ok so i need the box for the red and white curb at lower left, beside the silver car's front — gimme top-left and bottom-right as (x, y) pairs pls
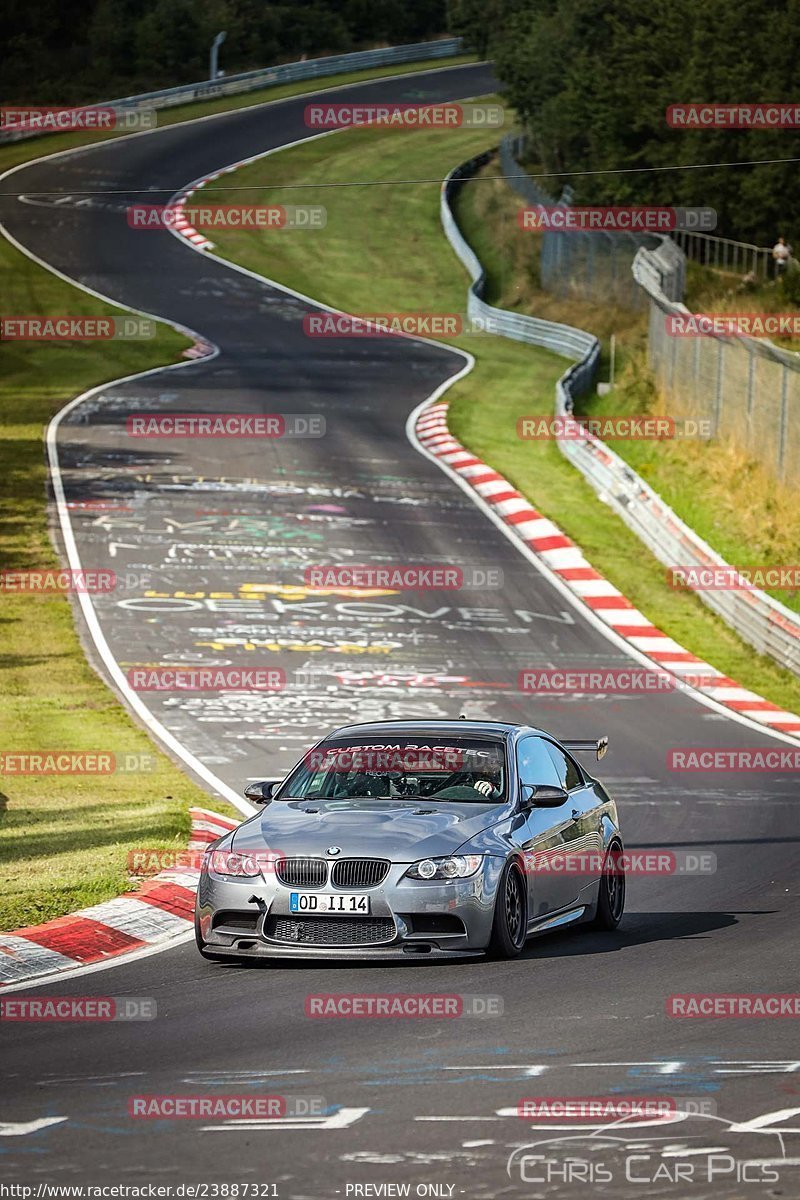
(0, 809), (239, 988)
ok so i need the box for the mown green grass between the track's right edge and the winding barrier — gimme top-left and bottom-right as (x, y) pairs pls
(204, 108), (800, 710)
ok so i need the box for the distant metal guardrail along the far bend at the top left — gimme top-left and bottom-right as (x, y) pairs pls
(0, 37), (463, 142)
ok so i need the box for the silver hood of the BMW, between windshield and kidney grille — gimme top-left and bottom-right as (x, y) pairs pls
(233, 799), (509, 863)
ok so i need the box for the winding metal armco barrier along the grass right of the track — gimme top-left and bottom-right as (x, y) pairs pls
(441, 151), (800, 674)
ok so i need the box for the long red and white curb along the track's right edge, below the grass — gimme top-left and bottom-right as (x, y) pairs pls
(415, 401), (800, 734)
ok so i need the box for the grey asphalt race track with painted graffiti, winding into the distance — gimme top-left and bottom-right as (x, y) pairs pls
(0, 66), (800, 1200)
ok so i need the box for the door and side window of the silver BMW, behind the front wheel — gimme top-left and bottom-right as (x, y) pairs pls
(517, 734), (579, 920)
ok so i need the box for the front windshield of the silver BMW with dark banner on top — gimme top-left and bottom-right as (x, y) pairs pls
(277, 737), (506, 804)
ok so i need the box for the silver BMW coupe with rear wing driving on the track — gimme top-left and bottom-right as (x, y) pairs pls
(194, 720), (625, 960)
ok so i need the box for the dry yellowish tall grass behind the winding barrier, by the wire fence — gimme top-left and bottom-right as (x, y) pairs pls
(459, 152), (800, 612)
